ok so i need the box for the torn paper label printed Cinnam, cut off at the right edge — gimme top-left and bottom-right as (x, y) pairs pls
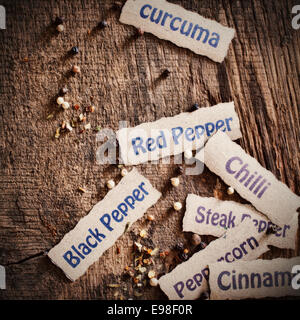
(209, 257), (300, 300)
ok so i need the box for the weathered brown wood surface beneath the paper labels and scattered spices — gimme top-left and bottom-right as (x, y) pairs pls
(0, 0), (300, 299)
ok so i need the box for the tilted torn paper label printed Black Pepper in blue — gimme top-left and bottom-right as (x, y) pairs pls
(48, 169), (161, 281)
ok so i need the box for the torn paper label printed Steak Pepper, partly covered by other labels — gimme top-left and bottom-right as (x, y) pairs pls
(183, 194), (298, 249)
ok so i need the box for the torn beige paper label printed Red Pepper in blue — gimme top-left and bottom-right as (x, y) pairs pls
(117, 102), (241, 165)
